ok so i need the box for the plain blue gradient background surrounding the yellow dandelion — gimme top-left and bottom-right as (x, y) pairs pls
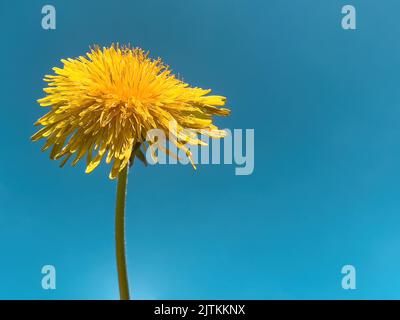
(0, 0), (400, 299)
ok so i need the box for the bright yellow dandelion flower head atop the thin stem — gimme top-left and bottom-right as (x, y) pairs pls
(31, 45), (230, 179)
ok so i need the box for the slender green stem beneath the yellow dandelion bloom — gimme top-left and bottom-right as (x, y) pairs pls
(115, 165), (129, 300)
